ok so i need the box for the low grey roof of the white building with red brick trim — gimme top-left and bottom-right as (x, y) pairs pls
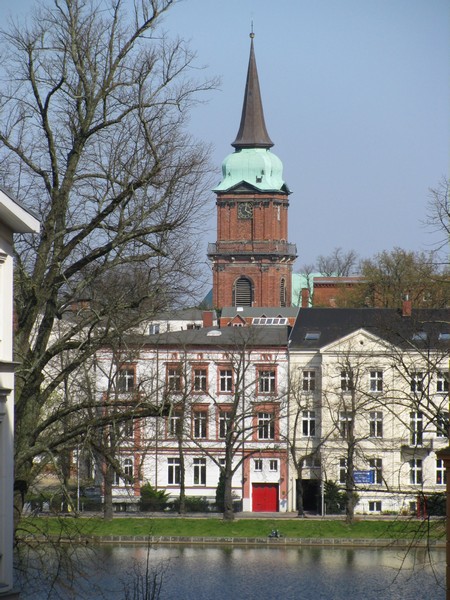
(127, 326), (288, 350)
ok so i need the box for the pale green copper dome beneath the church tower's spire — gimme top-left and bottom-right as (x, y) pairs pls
(214, 148), (286, 192)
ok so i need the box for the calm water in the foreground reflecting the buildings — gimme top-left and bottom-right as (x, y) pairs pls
(15, 545), (445, 600)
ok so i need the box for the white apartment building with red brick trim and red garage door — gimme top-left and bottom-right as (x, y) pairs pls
(96, 325), (288, 512)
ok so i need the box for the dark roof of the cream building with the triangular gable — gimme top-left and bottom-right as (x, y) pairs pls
(290, 308), (450, 351)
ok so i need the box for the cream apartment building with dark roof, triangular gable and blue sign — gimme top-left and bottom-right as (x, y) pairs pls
(289, 305), (450, 514)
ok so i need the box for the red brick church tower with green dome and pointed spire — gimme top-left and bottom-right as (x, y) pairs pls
(208, 33), (297, 308)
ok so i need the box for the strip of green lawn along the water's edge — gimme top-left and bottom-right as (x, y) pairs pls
(16, 517), (445, 539)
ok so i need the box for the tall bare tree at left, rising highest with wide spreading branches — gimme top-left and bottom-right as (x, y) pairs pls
(0, 0), (215, 510)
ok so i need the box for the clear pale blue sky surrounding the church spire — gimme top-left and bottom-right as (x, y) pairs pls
(0, 0), (450, 270)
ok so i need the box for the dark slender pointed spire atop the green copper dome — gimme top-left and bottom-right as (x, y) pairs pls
(231, 33), (273, 150)
